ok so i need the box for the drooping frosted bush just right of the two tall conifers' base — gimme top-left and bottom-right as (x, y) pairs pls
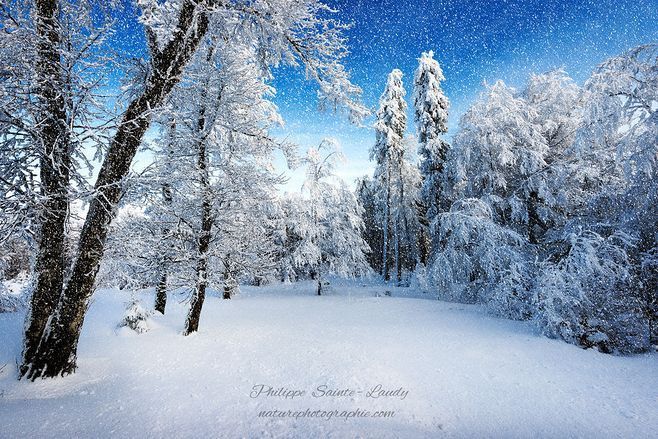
(429, 198), (532, 318)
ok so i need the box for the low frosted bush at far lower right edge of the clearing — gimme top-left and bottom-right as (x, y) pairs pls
(536, 231), (649, 352)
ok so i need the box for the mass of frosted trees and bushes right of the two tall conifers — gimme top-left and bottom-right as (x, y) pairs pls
(428, 45), (658, 353)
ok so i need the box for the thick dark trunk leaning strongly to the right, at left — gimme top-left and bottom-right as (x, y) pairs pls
(21, 0), (208, 380)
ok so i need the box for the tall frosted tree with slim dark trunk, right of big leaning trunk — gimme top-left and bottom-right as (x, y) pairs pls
(168, 43), (280, 334)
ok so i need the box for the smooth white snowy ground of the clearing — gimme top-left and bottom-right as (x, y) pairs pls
(0, 283), (658, 438)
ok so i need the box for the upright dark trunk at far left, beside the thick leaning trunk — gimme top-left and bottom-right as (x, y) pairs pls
(20, 0), (71, 376)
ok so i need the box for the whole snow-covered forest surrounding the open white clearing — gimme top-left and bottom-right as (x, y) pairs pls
(0, 0), (658, 380)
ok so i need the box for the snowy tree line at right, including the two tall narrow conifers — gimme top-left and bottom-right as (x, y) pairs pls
(358, 44), (658, 353)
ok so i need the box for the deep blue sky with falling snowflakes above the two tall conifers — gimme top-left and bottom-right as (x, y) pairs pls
(266, 0), (658, 190)
